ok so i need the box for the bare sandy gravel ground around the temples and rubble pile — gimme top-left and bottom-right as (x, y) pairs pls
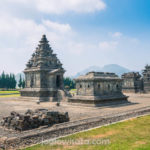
(0, 94), (150, 138)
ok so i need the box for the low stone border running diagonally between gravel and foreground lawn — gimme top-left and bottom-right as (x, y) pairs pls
(0, 107), (150, 149)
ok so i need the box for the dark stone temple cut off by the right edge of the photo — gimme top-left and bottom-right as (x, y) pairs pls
(143, 65), (150, 93)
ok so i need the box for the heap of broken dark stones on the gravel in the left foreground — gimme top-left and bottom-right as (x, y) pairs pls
(1, 109), (69, 131)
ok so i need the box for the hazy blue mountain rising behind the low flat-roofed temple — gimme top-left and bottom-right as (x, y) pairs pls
(74, 64), (131, 78)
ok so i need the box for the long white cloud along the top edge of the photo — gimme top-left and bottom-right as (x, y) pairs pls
(6, 0), (106, 14)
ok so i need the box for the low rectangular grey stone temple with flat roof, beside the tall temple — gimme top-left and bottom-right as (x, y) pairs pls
(69, 72), (127, 104)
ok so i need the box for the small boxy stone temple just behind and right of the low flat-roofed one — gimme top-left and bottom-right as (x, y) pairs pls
(122, 72), (143, 93)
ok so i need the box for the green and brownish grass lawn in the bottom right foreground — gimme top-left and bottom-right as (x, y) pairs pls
(26, 116), (150, 150)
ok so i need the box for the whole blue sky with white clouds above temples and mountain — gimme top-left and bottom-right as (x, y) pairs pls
(0, 0), (150, 76)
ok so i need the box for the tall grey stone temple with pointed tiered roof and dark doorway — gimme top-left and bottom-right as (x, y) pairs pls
(21, 35), (65, 101)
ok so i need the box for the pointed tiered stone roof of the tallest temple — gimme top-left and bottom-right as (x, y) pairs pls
(25, 35), (63, 70)
